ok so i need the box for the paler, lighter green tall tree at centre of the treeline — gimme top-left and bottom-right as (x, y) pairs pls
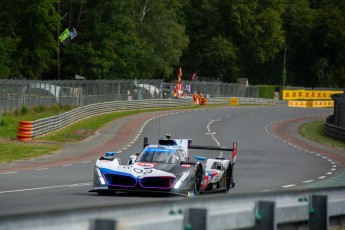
(133, 0), (189, 78)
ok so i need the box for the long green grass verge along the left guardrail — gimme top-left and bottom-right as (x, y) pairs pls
(0, 106), (203, 164)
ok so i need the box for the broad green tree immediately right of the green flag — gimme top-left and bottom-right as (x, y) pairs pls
(62, 0), (141, 79)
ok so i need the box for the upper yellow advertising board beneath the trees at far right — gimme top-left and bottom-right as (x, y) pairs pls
(283, 89), (344, 100)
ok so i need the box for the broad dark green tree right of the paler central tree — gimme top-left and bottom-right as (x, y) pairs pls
(183, 0), (285, 82)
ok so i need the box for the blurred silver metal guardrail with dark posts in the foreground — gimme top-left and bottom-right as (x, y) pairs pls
(0, 187), (345, 230)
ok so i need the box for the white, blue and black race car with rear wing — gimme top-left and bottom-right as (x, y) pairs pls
(90, 135), (237, 196)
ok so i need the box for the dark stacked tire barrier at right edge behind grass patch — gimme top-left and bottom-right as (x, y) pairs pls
(324, 94), (345, 140)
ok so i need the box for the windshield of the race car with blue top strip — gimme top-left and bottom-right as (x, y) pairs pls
(136, 148), (180, 164)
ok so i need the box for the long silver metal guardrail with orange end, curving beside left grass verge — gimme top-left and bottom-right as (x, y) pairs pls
(22, 97), (281, 140)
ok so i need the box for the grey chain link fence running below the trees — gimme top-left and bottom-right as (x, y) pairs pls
(0, 79), (259, 114)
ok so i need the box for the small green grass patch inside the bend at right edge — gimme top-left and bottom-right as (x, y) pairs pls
(299, 120), (345, 149)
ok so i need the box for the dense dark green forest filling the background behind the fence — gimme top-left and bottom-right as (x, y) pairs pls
(0, 0), (345, 87)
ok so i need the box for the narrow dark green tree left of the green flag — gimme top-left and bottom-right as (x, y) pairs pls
(6, 0), (59, 79)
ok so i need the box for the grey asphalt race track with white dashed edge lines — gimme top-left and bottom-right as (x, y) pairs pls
(0, 106), (345, 216)
